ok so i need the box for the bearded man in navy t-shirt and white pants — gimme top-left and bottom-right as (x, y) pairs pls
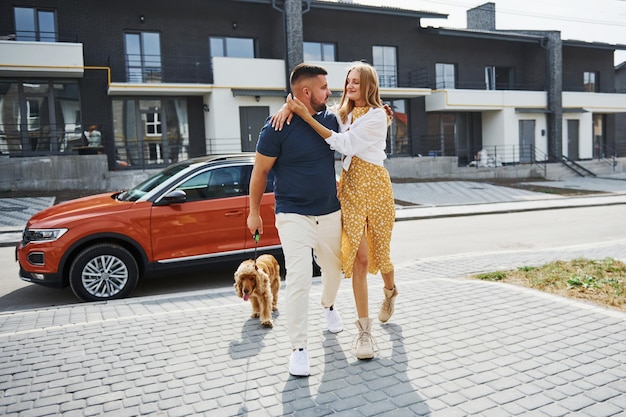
(248, 64), (343, 376)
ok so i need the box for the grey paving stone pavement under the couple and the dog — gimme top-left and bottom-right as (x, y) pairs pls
(0, 239), (626, 417)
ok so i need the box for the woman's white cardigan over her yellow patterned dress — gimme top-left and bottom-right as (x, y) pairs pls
(326, 108), (387, 171)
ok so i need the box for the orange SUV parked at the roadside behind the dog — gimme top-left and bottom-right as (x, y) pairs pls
(16, 153), (282, 301)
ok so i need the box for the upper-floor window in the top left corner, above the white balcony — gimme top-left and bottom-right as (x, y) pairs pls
(14, 7), (57, 42)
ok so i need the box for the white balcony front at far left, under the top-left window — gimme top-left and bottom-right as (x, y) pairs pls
(0, 41), (84, 78)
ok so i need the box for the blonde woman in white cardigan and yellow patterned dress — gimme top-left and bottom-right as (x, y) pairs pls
(287, 63), (398, 359)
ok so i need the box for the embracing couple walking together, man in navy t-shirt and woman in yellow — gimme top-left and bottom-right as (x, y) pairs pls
(247, 63), (398, 376)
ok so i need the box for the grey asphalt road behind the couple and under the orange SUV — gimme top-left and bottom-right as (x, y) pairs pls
(0, 205), (626, 312)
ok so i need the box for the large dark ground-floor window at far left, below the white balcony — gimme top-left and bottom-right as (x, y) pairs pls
(0, 80), (82, 155)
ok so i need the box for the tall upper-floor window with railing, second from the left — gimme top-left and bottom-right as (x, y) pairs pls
(124, 32), (162, 83)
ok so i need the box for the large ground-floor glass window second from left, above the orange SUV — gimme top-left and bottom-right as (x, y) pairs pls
(113, 97), (189, 169)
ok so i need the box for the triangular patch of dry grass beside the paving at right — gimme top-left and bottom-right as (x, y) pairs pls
(472, 258), (626, 312)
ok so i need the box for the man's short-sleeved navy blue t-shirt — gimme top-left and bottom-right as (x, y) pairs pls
(256, 110), (340, 216)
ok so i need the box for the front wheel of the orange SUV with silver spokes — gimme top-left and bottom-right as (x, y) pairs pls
(70, 243), (139, 301)
